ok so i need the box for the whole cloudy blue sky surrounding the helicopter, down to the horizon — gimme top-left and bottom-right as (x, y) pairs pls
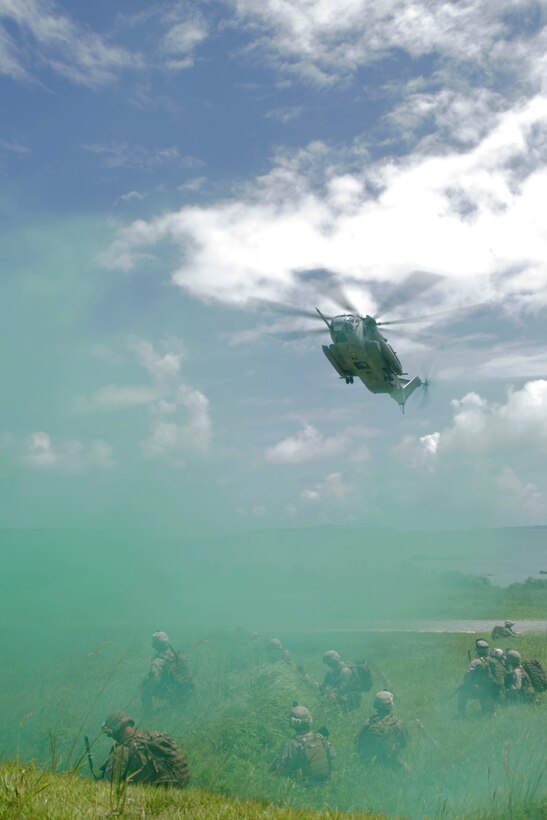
(0, 0), (547, 532)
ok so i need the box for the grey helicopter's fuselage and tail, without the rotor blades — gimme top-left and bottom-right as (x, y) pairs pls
(323, 314), (422, 407)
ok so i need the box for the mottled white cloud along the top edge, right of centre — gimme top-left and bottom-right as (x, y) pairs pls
(232, 0), (544, 90)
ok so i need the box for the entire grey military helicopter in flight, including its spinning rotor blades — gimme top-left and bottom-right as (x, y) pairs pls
(260, 271), (452, 413)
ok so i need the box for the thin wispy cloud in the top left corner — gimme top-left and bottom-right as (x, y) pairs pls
(0, 0), (142, 88)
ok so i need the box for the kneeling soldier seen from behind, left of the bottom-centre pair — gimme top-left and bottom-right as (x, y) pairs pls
(271, 706), (336, 782)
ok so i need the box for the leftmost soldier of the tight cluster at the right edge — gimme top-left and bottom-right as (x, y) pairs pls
(458, 638), (505, 717)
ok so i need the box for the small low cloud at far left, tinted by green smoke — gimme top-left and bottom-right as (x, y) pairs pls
(23, 432), (115, 473)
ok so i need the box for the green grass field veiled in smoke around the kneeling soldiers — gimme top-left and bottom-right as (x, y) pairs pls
(0, 629), (547, 817)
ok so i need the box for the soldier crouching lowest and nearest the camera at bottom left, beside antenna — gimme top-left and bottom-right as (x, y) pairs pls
(101, 712), (190, 789)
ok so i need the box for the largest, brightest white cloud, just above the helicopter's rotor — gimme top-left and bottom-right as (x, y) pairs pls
(109, 97), (547, 311)
